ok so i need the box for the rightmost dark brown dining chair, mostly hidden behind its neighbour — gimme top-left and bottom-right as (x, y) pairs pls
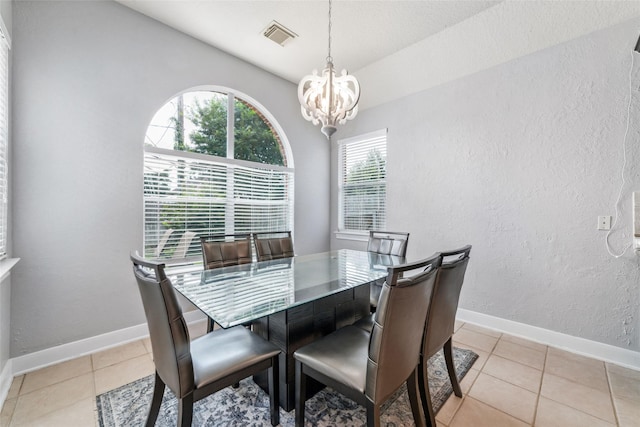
(418, 245), (471, 427)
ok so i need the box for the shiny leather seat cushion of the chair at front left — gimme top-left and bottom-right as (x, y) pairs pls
(191, 326), (280, 388)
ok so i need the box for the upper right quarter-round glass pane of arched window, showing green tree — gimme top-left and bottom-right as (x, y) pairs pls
(233, 99), (284, 165)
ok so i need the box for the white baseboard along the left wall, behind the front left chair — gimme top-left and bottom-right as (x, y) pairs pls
(9, 310), (206, 377)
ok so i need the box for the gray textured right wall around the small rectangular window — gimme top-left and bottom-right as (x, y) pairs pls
(332, 20), (640, 351)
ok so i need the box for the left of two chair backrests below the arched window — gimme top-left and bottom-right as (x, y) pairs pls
(200, 233), (252, 270)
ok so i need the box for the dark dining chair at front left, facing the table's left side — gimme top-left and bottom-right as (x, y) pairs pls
(130, 253), (280, 427)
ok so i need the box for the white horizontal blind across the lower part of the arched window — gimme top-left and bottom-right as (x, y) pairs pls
(144, 147), (294, 261)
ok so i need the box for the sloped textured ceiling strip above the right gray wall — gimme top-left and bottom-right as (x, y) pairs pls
(358, 0), (640, 108)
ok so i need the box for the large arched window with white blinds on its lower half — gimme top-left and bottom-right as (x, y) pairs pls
(144, 90), (293, 261)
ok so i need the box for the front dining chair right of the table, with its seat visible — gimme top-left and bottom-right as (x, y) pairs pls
(293, 254), (442, 427)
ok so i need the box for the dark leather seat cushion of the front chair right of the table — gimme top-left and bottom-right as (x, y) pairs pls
(293, 326), (370, 393)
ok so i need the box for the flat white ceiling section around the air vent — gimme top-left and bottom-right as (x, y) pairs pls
(116, 0), (500, 83)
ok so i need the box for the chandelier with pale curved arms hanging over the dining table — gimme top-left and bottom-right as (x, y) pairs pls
(298, 0), (360, 138)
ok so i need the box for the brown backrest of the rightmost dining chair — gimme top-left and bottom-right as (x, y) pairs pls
(422, 245), (471, 358)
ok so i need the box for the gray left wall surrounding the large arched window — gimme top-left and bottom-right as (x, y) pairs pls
(11, 1), (330, 357)
